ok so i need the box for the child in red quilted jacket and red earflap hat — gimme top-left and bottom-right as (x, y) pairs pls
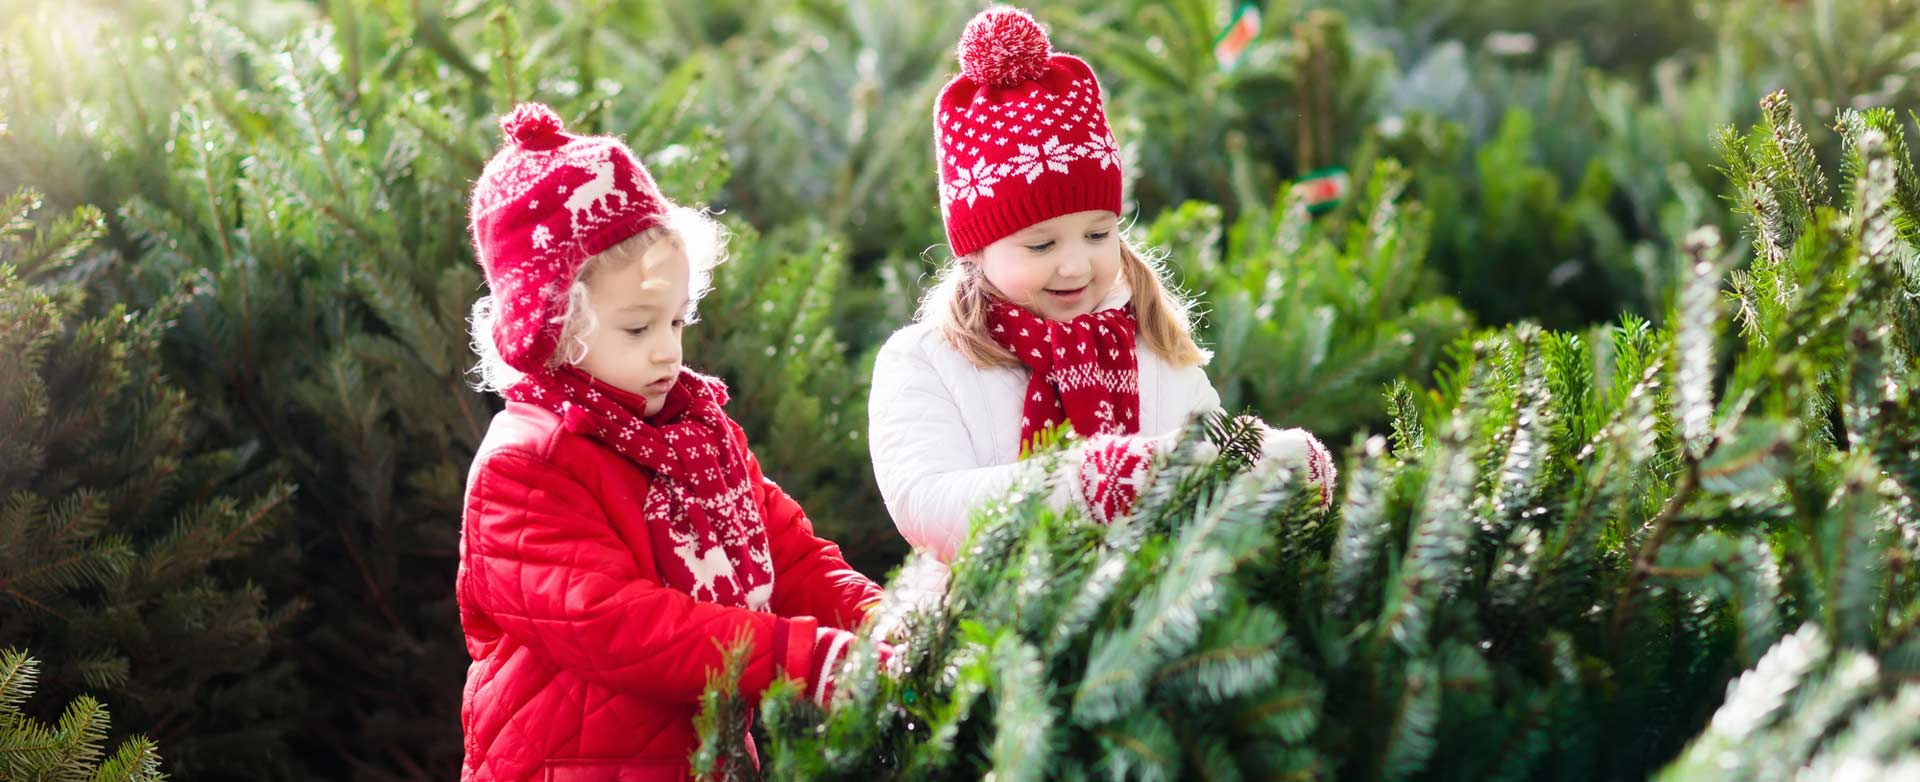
(457, 104), (879, 782)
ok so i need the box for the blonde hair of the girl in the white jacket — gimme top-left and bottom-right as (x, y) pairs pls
(914, 236), (1212, 369)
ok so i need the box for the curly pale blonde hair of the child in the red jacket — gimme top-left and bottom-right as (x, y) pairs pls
(467, 206), (728, 394)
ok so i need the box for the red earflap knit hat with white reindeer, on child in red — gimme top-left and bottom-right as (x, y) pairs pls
(470, 104), (672, 373)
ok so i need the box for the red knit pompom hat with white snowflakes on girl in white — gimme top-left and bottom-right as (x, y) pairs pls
(933, 6), (1121, 256)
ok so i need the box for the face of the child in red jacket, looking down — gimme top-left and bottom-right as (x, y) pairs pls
(578, 238), (689, 415)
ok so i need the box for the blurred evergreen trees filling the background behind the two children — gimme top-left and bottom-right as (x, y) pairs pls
(0, 0), (1920, 780)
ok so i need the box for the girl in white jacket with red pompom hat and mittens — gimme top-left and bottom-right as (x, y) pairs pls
(868, 8), (1334, 563)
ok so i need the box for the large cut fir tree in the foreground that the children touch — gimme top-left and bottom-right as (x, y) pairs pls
(701, 96), (1920, 780)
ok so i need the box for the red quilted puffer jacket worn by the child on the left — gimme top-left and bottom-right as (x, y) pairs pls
(457, 403), (879, 782)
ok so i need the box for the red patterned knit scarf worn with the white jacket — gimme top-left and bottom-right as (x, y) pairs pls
(989, 298), (1140, 453)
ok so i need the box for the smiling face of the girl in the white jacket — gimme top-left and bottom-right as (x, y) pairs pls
(970, 209), (1119, 321)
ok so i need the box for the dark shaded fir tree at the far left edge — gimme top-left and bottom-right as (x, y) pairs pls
(0, 183), (303, 776)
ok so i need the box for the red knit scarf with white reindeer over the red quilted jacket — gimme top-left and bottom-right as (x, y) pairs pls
(503, 367), (774, 611)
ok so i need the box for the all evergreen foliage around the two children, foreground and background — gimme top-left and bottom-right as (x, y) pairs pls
(0, 0), (1920, 780)
